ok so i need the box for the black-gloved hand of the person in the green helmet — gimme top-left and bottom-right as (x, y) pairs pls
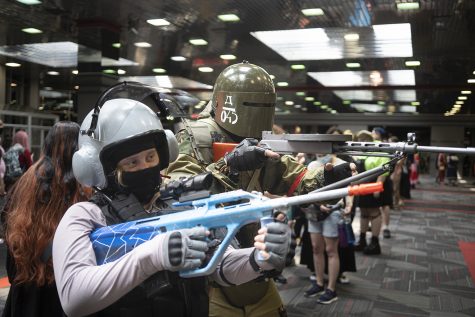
(224, 138), (267, 172)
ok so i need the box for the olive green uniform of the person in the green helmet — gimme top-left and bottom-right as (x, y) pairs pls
(167, 113), (324, 317)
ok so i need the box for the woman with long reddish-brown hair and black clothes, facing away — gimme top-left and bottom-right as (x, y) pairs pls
(2, 121), (88, 317)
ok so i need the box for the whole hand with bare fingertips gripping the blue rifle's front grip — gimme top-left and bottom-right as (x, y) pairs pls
(254, 222), (295, 271)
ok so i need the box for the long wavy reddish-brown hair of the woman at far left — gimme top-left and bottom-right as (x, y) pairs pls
(6, 121), (88, 286)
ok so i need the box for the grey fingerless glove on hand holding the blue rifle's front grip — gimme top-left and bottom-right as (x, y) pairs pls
(255, 222), (295, 271)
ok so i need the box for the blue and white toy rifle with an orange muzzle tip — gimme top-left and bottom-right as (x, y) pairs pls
(90, 183), (383, 277)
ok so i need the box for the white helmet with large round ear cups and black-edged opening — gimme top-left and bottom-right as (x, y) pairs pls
(73, 82), (178, 188)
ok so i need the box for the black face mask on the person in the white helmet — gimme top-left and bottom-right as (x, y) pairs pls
(122, 164), (162, 204)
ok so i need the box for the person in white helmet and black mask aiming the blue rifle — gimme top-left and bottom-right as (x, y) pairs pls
(53, 83), (288, 317)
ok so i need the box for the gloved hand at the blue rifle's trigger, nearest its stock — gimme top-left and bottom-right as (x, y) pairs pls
(162, 227), (209, 271)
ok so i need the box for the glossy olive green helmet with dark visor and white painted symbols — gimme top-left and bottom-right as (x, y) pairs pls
(211, 61), (276, 139)
